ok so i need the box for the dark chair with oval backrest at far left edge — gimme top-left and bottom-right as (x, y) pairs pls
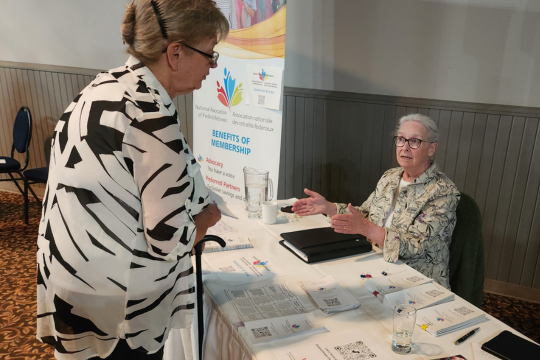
(0, 106), (32, 221)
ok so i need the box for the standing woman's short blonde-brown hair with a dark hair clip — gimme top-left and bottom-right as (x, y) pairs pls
(121, 0), (229, 65)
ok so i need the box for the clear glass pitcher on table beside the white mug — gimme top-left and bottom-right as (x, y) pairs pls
(244, 166), (274, 215)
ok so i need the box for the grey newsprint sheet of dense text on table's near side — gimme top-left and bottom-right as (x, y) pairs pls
(225, 284), (315, 322)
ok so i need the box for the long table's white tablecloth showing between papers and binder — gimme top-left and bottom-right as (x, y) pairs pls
(164, 200), (526, 360)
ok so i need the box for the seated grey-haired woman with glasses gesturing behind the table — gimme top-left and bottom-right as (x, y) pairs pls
(293, 114), (460, 289)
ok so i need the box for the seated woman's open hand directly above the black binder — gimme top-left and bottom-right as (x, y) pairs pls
(330, 204), (385, 248)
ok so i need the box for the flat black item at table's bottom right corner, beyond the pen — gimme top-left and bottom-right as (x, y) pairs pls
(482, 330), (540, 360)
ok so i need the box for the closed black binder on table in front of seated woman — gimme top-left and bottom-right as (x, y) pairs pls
(279, 227), (372, 264)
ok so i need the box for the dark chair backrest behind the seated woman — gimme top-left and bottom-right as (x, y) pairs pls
(450, 193), (485, 308)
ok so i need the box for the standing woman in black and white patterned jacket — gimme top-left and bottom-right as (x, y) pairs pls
(37, 0), (229, 359)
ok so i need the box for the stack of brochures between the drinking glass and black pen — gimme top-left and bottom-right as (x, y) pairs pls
(416, 298), (488, 336)
